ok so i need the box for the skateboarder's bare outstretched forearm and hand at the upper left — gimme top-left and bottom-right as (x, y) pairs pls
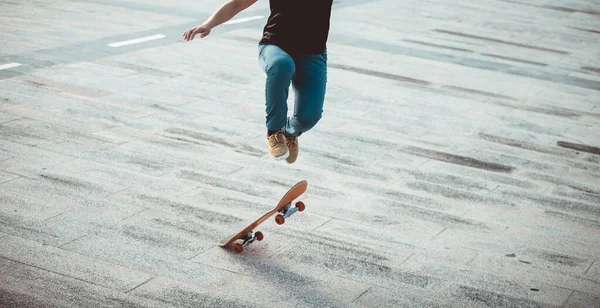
(183, 0), (258, 41)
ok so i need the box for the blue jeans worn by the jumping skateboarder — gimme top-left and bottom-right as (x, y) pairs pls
(258, 45), (327, 137)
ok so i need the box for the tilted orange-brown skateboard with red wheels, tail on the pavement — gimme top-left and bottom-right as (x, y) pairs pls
(218, 180), (308, 253)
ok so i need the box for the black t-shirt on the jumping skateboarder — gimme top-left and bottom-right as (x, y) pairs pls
(259, 0), (333, 54)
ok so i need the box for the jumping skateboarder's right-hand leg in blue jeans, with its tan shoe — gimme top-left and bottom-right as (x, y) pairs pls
(284, 51), (327, 163)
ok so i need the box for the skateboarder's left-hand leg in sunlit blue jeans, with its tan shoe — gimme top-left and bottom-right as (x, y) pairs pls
(259, 45), (296, 158)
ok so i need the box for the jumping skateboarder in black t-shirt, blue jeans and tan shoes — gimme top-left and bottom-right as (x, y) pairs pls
(183, 0), (333, 163)
